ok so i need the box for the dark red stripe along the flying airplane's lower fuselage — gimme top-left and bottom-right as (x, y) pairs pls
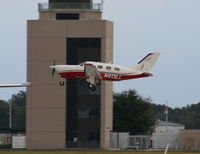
(59, 72), (152, 81)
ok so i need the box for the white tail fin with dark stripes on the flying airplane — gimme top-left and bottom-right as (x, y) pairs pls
(133, 52), (160, 73)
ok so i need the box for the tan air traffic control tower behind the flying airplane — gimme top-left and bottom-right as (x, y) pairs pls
(26, 0), (113, 149)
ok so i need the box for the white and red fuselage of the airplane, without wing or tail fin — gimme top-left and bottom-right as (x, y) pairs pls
(52, 61), (152, 81)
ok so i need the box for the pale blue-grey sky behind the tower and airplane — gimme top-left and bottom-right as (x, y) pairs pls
(0, 0), (200, 107)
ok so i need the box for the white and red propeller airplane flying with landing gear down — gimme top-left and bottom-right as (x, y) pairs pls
(49, 52), (160, 91)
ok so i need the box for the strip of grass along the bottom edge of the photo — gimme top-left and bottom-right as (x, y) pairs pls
(0, 150), (200, 154)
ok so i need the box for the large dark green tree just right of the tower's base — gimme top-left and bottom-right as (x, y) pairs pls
(113, 90), (156, 134)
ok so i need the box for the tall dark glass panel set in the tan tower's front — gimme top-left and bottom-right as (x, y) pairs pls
(66, 38), (101, 148)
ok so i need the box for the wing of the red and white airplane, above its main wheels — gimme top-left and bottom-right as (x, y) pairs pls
(85, 64), (102, 85)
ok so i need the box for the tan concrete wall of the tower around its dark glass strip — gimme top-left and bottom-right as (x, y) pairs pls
(26, 20), (113, 149)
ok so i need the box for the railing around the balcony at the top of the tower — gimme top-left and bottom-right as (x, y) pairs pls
(38, 3), (103, 12)
